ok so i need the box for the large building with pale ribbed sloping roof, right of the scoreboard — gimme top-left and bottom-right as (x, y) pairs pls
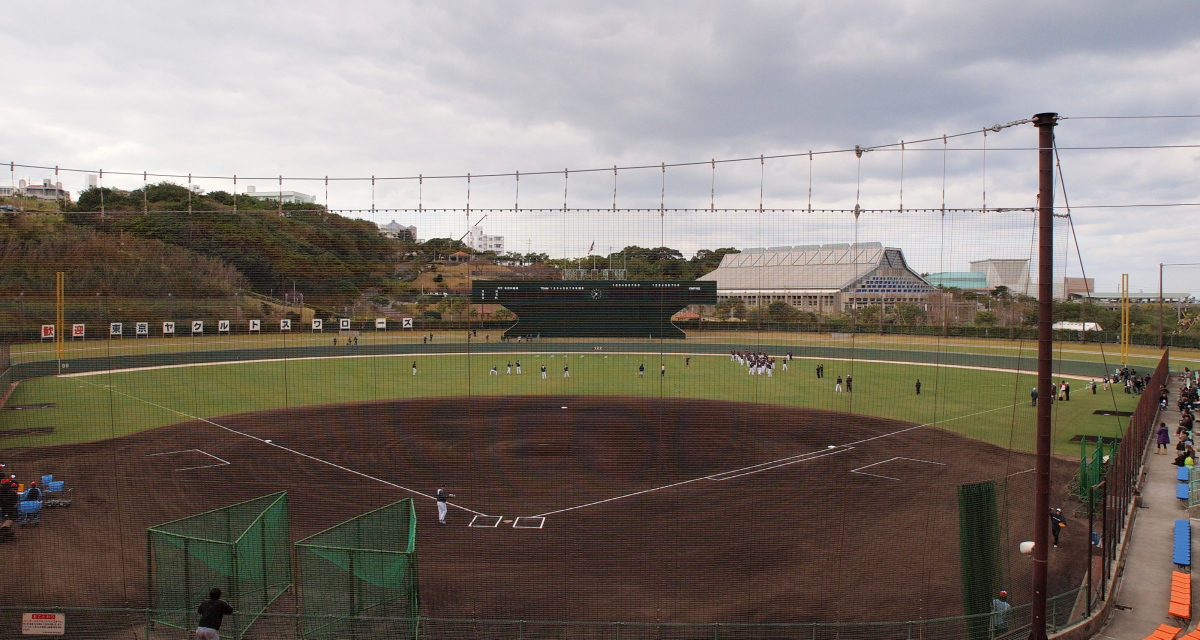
(697, 243), (936, 313)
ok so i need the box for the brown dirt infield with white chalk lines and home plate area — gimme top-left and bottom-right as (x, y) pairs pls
(0, 396), (1087, 623)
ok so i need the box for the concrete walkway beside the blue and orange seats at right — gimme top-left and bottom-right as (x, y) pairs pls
(1096, 377), (1196, 640)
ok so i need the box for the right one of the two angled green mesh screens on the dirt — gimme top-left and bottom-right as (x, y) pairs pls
(296, 498), (420, 639)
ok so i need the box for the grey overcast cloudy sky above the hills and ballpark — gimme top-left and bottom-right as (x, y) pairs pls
(0, 0), (1200, 292)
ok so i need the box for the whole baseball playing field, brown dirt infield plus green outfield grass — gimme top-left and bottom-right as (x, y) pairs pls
(0, 331), (1152, 622)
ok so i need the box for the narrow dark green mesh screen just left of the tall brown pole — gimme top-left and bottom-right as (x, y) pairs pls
(959, 480), (1002, 640)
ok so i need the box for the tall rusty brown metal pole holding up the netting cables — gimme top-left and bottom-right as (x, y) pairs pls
(1030, 113), (1058, 640)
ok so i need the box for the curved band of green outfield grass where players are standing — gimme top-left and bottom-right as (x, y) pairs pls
(0, 345), (1138, 455)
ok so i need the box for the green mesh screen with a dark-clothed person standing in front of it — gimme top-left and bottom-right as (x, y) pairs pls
(149, 491), (292, 638)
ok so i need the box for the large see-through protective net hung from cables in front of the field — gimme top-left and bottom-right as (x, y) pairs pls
(0, 121), (1180, 638)
